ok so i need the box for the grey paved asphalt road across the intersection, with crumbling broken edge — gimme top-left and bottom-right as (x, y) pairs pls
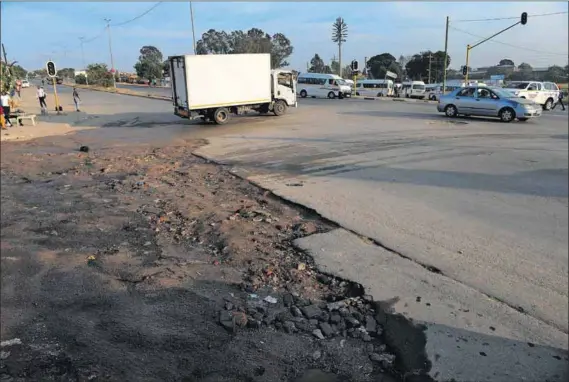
(16, 86), (569, 381)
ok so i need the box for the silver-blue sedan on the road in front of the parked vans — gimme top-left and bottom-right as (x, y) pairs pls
(437, 86), (541, 122)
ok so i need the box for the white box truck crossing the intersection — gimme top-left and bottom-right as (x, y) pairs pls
(168, 54), (297, 125)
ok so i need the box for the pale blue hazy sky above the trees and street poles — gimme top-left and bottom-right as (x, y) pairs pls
(1, 1), (569, 71)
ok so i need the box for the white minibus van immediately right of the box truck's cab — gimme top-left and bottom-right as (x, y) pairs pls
(296, 73), (352, 98)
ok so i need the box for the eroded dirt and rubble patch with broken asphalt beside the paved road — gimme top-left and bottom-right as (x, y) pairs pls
(0, 137), (408, 382)
